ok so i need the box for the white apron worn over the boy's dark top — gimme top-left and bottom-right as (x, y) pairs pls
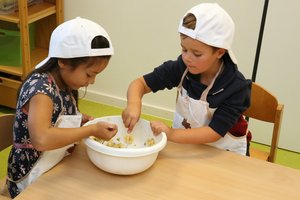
(173, 66), (247, 155)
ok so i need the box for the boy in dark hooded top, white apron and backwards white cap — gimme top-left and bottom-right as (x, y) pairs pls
(122, 3), (251, 155)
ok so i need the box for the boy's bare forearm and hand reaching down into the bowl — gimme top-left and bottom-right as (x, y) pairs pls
(122, 77), (151, 132)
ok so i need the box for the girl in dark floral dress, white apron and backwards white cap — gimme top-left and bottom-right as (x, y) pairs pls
(7, 17), (117, 198)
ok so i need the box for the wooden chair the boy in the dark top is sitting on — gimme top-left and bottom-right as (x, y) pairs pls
(244, 82), (284, 162)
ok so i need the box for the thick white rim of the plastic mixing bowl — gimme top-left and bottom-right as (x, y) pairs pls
(84, 116), (167, 157)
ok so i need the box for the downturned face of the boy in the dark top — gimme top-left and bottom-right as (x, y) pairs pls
(180, 36), (224, 74)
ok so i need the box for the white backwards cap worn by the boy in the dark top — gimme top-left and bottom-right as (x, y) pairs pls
(178, 3), (237, 64)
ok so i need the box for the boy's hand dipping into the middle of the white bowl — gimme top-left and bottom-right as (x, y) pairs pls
(122, 105), (141, 133)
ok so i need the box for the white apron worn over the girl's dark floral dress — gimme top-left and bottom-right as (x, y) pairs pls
(14, 84), (82, 192)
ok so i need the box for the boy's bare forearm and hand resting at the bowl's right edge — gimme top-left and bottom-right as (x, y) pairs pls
(151, 121), (221, 144)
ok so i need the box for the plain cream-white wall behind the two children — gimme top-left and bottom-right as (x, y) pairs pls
(65, 0), (300, 152)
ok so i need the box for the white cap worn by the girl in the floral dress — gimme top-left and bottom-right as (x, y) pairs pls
(35, 17), (114, 68)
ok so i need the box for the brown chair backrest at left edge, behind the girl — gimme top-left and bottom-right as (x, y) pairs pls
(0, 114), (15, 151)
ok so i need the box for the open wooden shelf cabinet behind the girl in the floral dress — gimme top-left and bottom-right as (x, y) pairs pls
(0, 0), (63, 108)
